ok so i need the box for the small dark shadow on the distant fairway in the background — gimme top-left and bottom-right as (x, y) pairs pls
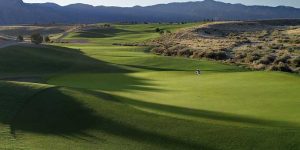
(74, 28), (135, 38)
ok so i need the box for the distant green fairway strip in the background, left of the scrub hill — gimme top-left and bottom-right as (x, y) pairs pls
(65, 23), (199, 46)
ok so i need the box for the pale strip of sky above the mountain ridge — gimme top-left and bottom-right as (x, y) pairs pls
(23, 0), (300, 8)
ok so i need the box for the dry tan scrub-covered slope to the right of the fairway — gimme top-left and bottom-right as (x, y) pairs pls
(150, 20), (300, 73)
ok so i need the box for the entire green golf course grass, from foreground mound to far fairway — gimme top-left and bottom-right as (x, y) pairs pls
(0, 23), (300, 150)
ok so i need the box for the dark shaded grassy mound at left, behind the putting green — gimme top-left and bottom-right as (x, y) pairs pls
(0, 45), (130, 74)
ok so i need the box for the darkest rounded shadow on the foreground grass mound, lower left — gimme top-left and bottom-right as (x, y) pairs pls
(11, 87), (97, 135)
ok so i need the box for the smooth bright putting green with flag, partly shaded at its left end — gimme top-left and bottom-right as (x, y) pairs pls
(49, 71), (300, 125)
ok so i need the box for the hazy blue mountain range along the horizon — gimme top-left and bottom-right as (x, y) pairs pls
(0, 0), (300, 25)
